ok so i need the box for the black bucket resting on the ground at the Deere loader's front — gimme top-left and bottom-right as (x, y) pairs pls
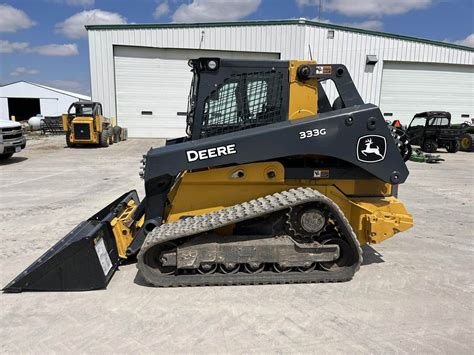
(3, 190), (140, 292)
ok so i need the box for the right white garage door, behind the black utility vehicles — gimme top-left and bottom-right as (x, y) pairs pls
(380, 62), (474, 124)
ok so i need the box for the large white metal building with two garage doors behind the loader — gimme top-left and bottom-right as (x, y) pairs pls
(87, 19), (474, 137)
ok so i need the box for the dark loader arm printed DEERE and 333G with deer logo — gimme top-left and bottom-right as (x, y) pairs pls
(144, 104), (408, 230)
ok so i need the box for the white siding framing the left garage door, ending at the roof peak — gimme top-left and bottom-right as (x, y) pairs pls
(88, 25), (305, 116)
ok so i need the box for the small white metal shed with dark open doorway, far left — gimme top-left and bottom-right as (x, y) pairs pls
(0, 81), (90, 121)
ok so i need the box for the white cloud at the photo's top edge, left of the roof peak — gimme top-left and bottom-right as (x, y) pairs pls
(173, 0), (261, 22)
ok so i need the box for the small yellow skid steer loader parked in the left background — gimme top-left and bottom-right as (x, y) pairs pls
(62, 101), (127, 147)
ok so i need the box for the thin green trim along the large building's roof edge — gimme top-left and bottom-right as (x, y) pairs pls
(86, 19), (474, 52)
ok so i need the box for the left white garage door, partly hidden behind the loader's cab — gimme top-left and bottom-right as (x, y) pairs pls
(114, 47), (279, 138)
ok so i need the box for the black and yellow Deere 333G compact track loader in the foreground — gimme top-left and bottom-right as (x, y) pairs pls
(4, 58), (413, 292)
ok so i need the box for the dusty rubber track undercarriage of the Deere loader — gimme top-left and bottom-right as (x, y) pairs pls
(138, 188), (362, 286)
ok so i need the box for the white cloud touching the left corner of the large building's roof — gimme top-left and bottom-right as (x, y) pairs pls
(55, 9), (127, 38)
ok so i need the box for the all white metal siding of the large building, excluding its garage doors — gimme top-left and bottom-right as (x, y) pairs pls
(89, 22), (474, 132)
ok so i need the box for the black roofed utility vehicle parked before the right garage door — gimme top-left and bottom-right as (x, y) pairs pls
(407, 111), (462, 153)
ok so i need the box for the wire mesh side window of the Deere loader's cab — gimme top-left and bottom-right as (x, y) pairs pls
(201, 72), (283, 137)
